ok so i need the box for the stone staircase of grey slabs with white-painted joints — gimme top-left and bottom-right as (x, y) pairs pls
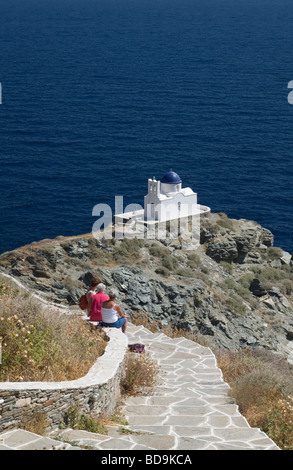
(0, 324), (279, 450)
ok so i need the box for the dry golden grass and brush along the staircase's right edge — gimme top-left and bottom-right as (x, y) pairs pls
(215, 349), (293, 450)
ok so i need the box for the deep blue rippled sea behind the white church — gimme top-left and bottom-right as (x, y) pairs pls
(0, 0), (293, 252)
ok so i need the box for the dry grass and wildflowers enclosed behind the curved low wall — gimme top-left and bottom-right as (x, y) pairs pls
(0, 282), (107, 382)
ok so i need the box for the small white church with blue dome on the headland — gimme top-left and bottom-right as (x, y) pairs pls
(115, 170), (210, 233)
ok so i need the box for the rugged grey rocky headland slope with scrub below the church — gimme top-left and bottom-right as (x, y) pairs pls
(0, 214), (293, 362)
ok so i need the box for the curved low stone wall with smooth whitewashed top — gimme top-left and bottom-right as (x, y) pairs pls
(0, 328), (128, 432)
